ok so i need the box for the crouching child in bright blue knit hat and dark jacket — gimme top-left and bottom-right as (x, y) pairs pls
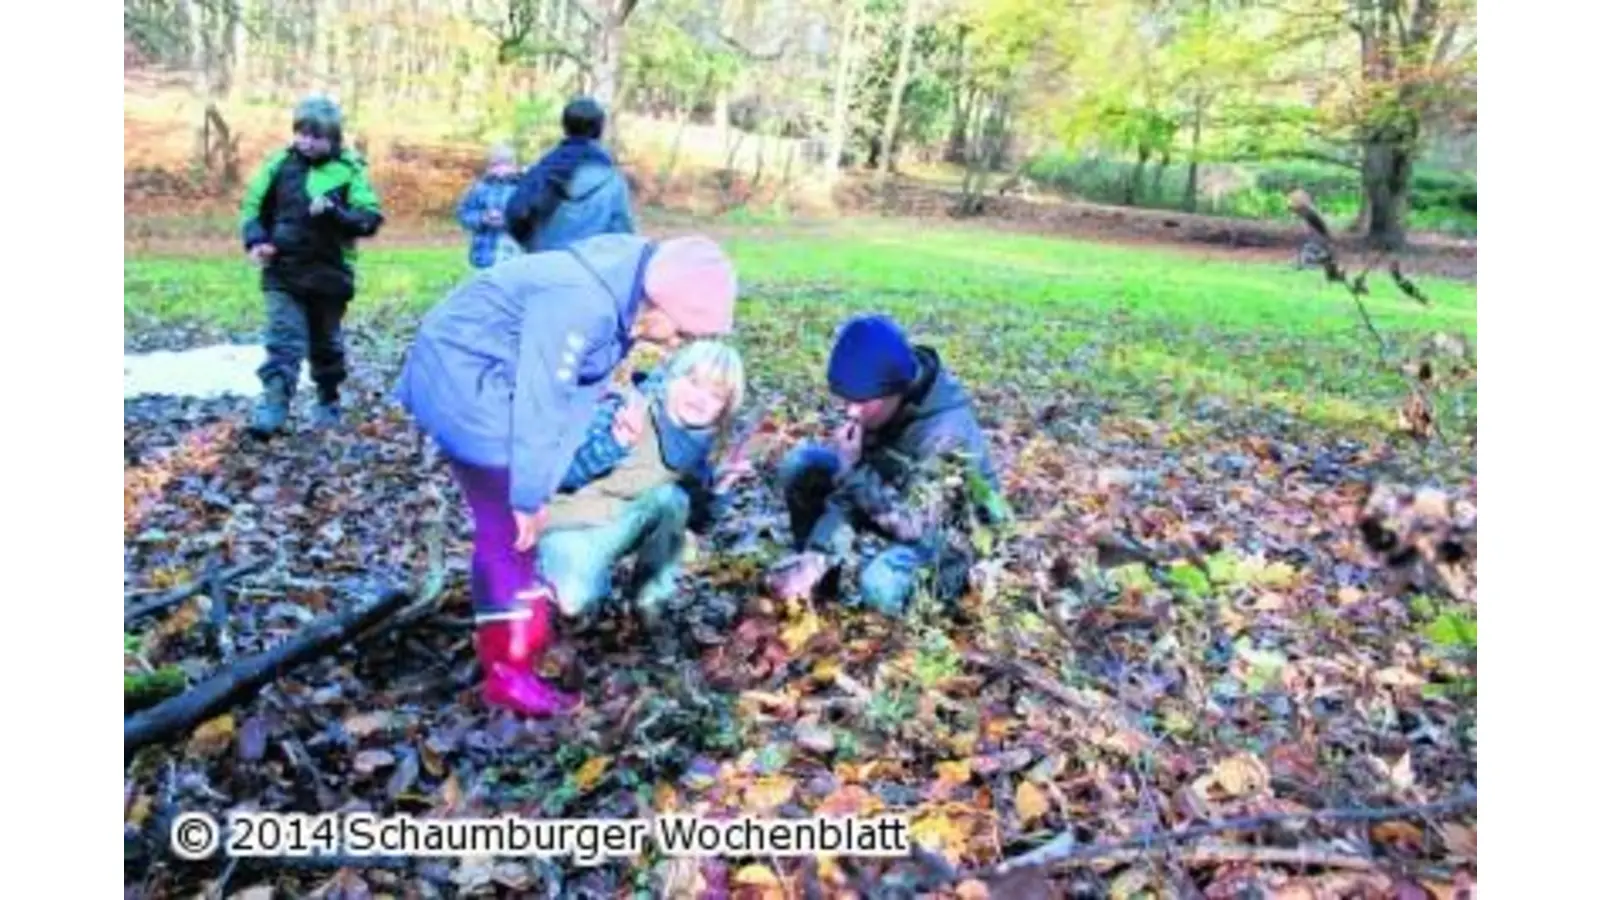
(771, 315), (1010, 617)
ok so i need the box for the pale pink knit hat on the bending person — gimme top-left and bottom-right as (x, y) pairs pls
(645, 235), (739, 336)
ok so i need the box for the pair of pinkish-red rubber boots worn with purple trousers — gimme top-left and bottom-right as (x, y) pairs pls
(477, 597), (579, 719)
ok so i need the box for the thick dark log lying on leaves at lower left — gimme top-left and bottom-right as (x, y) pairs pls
(122, 591), (410, 759)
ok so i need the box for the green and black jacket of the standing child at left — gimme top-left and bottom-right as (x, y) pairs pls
(240, 147), (384, 303)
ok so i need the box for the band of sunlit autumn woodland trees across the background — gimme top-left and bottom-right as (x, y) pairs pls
(123, 0), (1475, 240)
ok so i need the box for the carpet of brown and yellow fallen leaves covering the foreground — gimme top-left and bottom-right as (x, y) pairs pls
(128, 281), (1475, 898)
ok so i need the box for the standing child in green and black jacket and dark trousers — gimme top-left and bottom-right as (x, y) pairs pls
(240, 96), (384, 437)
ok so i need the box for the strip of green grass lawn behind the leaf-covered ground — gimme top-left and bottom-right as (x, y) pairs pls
(123, 217), (1477, 454)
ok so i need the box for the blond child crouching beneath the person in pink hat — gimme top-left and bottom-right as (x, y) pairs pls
(539, 341), (744, 626)
